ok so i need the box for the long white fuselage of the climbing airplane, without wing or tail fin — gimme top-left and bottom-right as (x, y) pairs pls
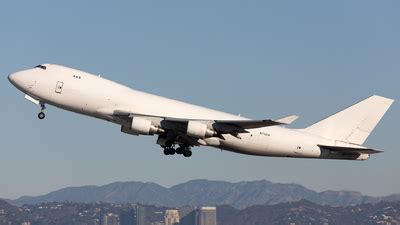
(9, 64), (368, 160)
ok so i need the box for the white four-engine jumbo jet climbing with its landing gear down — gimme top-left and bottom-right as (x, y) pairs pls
(8, 64), (394, 160)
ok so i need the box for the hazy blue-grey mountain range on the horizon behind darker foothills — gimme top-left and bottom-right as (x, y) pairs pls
(3, 180), (400, 209)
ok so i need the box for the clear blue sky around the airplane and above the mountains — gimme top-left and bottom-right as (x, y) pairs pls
(0, 0), (400, 198)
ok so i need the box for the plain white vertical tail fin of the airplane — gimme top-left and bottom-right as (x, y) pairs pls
(304, 95), (394, 145)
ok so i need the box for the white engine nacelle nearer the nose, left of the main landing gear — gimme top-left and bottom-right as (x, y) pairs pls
(121, 117), (163, 135)
